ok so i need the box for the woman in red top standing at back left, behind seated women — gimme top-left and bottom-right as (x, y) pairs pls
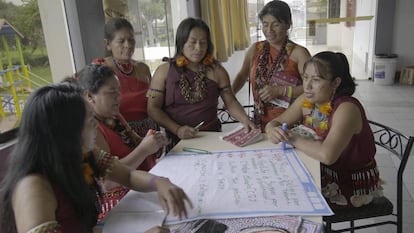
(92, 18), (158, 171)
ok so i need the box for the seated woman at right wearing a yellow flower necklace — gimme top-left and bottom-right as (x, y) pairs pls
(266, 52), (382, 209)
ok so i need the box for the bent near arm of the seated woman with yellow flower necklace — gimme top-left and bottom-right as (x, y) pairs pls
(288, 102), (362, 165)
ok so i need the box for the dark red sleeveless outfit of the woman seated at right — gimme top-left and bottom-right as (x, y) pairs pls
(306, 96), (381, 209)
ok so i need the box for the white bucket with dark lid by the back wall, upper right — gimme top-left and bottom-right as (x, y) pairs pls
(374, 54), (397, 85)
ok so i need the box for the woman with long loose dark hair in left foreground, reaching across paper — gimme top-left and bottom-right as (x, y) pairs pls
(0, 83), (191, 233)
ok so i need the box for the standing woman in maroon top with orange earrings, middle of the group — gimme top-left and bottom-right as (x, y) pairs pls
(148, 18), (254, 147)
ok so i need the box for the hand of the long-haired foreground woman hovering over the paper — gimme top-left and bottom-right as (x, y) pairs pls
(154, 177), (193, 220)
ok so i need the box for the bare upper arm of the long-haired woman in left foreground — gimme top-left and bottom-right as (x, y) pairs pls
(12, 175), (57, 233)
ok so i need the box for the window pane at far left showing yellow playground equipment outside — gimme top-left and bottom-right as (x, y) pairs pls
(0, 0), (52, 142)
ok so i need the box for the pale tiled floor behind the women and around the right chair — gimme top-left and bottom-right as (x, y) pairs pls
(223, 51), (414, 233)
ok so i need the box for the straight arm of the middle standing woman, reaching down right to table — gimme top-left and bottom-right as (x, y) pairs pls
(214, 65), (256, 129)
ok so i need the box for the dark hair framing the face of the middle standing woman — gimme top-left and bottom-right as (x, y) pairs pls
(174, 18), (214, 57)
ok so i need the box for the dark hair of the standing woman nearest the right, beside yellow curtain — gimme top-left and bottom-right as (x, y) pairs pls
(259, 0), (292, 25)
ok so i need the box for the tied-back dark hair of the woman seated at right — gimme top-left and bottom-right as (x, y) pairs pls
(303, 51), (356, 97)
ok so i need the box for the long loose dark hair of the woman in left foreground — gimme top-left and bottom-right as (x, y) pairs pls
(0, 83), (97, 233)
